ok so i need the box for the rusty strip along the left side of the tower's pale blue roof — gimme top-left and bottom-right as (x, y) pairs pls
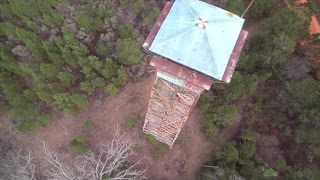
(142, 1), (173, 49)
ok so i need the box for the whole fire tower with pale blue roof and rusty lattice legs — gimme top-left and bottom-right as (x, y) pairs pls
(143, 0), (248, 148)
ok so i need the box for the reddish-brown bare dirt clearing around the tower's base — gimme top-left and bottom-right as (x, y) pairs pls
(1, 74), (240, 180)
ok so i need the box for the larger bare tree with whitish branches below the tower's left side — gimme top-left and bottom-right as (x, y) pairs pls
(43, 130), (146, 180)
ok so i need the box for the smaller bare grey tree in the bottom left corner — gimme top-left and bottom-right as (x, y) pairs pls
(2, 150), (36, 180)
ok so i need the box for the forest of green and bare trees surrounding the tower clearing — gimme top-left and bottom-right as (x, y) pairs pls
(0, 0), (320, 180)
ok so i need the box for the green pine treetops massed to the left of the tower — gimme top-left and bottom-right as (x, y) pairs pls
(0, 0), (135, 132)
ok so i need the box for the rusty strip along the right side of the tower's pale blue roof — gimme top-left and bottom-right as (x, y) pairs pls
(221, 30), (248, 83)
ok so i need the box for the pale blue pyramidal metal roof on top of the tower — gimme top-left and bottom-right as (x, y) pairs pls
(149, 0), (244, 80)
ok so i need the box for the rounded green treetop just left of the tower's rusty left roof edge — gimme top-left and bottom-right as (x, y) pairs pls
(116, 39), (143, 65)
